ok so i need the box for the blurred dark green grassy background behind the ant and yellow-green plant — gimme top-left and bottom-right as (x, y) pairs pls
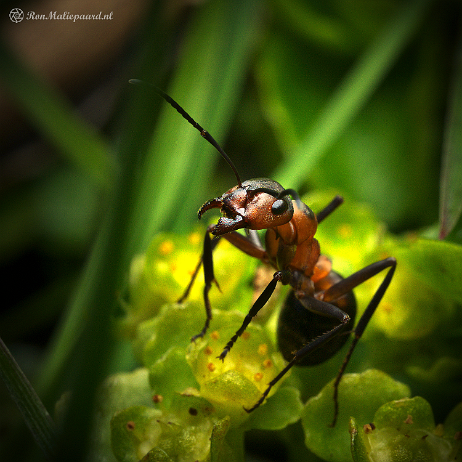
(0, 0), (462, 460)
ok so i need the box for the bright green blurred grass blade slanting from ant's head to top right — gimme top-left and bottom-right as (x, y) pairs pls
(274, 0), (430, 189)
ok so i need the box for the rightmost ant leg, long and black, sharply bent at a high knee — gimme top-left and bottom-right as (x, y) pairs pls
(324, 257), (396, 427)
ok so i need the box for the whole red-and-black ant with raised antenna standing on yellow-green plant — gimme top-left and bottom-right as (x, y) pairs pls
(130, 80), (396, 427)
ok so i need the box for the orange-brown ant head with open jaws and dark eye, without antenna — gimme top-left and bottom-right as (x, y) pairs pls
(198, 178), (294, 236)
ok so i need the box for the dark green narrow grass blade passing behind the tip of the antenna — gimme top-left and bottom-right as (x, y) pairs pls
(37, 11), (165, 401)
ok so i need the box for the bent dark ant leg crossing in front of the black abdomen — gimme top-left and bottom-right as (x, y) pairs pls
(244, 297), (350, 412)
